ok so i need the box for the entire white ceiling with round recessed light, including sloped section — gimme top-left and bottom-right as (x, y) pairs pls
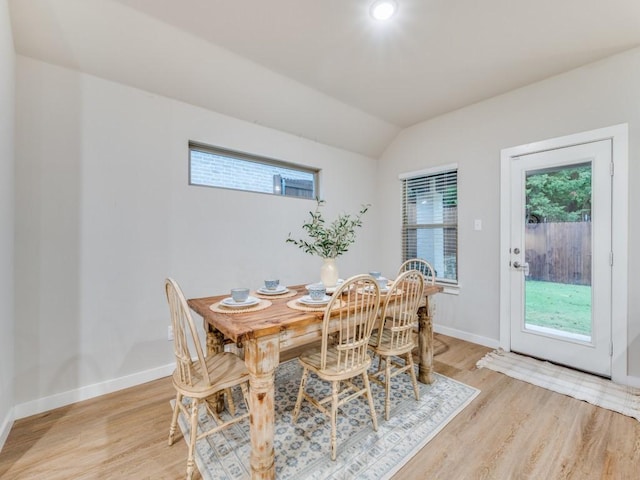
(10, 0), (640, 156)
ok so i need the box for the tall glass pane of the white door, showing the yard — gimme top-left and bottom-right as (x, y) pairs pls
(524, 162), (592, 342)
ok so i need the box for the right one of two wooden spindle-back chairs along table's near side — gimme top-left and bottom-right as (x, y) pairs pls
(369, 270), (424, 420)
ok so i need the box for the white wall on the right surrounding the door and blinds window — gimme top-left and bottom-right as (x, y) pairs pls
(378, 49), (640, 377)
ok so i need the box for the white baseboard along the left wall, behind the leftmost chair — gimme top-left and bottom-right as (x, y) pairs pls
(13, 363), (175, 419)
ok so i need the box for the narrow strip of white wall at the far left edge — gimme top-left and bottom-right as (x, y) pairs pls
(0, 0), (15, 448)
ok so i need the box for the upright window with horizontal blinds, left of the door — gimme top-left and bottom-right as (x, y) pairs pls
(400, 165), (458, 284)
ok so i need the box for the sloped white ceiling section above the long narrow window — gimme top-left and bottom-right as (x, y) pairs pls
(11, 0), (400, 156)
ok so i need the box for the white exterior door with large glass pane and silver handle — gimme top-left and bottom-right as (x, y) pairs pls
(509, 140), (612, 376)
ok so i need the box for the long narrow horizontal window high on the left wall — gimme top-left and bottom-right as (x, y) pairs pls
(189, 142), (318, 198)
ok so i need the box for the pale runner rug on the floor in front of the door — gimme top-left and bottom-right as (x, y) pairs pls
(477, 349), (640, 420)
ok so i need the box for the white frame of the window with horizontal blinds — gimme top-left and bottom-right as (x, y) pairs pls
(398, 163), (460, 287)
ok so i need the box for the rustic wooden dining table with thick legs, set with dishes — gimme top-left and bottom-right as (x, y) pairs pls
(188, 285), (442, 479)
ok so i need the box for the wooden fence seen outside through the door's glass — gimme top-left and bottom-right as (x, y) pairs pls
(525, 222), (591, 285)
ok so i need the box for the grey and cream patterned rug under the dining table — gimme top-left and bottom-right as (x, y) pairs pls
(172, 360), (480, 480)
